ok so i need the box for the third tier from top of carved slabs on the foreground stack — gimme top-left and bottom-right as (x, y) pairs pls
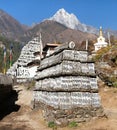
(35, 76), (98, 92)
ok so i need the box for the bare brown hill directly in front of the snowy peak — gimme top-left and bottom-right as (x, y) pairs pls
(28, 20), (96, 44)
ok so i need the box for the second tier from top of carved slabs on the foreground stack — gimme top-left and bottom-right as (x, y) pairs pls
(35, 61), (95, 79)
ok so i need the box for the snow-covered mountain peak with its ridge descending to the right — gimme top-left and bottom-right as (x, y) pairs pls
(49, 8), (97, 34)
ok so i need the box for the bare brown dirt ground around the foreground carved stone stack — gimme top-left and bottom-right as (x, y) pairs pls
(0, 82), (117, 130)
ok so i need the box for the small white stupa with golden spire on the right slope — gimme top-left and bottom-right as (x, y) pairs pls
(94, 27), (108, 52)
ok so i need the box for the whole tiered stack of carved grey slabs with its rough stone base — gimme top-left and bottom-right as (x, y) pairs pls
(34, 42), (102, 124)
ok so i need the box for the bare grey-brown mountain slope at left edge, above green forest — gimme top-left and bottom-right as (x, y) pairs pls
(0, 9), (26, 40)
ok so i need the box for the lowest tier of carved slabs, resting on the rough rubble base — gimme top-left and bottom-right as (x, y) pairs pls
(33, 91), (101, 109)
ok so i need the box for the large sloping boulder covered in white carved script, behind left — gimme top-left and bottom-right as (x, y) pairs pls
(7, 37), (42, 83)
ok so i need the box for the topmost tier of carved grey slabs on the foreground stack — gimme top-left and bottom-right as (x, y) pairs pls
(38, 50), (88, 70)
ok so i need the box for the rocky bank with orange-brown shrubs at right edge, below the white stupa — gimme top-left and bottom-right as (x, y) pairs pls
(94, 44), (117, 87)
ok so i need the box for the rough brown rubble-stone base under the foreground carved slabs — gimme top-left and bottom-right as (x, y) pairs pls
(35, 101), (104, 126)
